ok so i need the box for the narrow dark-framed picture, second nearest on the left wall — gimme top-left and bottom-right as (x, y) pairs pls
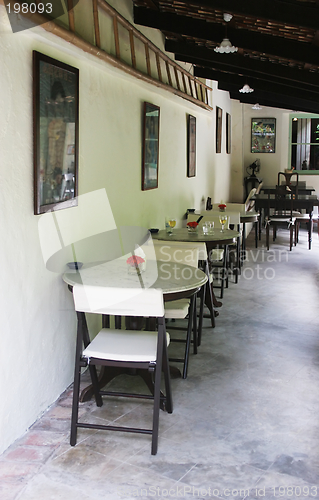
(142, 102), (160, 191)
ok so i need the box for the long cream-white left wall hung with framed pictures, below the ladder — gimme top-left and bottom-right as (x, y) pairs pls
(0, 6), (230, 453)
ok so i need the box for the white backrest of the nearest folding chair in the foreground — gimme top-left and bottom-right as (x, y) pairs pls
(73, 285), (164, 318)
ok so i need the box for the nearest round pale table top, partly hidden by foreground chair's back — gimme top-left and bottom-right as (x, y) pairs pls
(63, 258), (207, 300)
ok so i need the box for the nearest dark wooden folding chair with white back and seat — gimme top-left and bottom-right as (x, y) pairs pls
(70, 285), (173, 455)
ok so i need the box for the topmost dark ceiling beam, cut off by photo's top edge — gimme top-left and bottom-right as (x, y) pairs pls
(160, 0), (319, 30)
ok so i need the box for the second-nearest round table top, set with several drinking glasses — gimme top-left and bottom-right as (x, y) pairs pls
(152, 228), (240, 245)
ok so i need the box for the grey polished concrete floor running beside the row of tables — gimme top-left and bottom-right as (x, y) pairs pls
(0, 231), (319, 500)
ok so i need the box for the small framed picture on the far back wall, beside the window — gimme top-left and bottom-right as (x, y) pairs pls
(251, 118), (276, 153)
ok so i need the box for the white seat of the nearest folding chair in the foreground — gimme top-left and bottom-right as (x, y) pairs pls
(83, 328), (170, 362)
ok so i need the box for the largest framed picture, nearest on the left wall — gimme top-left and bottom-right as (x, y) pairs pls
(33, 51), (79, 215)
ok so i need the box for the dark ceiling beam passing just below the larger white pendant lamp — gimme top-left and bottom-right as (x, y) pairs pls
(165, 40), (319, 87)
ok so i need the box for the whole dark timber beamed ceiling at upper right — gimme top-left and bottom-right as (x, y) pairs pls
(133, 0), (319, 113)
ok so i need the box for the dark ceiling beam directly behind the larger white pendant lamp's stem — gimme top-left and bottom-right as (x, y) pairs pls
(134, 7), (319, 65)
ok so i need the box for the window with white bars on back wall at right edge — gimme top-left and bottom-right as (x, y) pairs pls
(290, 114), (319, 171)
